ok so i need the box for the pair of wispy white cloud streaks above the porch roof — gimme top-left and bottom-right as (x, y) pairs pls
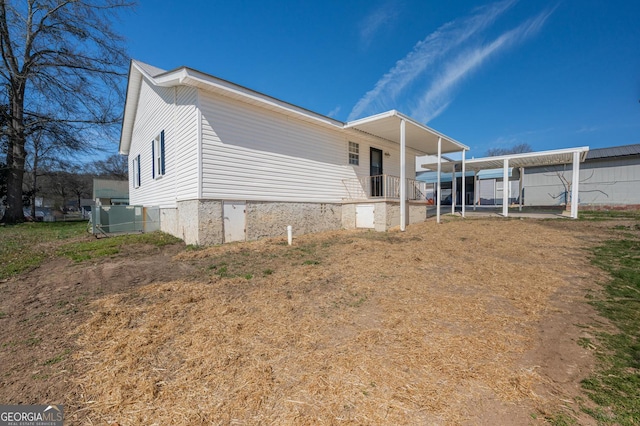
(348, 0), (553, 121)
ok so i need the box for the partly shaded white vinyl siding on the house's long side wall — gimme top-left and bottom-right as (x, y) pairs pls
(200, 92), (356, 202)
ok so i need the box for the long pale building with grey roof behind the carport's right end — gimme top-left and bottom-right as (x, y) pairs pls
(524, 144), (640, 207)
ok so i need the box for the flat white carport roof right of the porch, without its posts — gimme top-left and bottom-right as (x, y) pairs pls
(422, 146), (589, 171)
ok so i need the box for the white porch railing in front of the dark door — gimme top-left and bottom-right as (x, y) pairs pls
(342, 175), (429, 201)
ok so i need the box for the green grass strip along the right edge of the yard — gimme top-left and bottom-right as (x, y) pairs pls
(579, 225), (640, 425)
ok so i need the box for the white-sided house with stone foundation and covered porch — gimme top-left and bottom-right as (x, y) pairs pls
(120, 61), (468, 244)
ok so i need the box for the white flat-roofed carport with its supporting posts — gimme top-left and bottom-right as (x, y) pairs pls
(422, 146), (589, 222)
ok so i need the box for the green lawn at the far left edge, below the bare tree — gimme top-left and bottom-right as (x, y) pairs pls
(0, 222), (87, 279)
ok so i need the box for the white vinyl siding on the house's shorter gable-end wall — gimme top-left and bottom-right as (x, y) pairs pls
(130, 80), (198, 207)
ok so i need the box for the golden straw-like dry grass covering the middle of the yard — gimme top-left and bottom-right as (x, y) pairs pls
(71, 220), (596, 425)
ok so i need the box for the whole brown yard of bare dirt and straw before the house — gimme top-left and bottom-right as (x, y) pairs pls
(0, 219), (612, 425)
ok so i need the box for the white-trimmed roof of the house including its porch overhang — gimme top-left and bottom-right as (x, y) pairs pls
(119, 60), (469, 155)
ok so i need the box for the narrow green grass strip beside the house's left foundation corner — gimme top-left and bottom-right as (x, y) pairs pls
(58, 231), (181, 262)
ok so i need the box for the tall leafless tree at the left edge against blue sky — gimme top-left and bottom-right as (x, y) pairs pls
(0, 0), (132, 222)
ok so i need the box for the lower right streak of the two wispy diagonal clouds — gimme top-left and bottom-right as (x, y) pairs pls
(411, 7), (552, 122)
